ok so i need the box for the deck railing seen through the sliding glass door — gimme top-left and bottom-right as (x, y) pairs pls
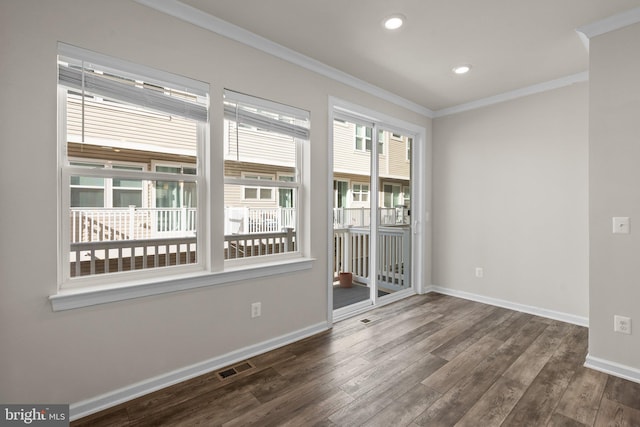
(333, 226), (411, 290)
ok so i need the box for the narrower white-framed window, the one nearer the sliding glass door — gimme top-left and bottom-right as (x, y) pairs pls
(224, 90), (309, 263)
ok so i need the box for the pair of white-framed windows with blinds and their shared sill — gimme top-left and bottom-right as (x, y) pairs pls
(50, 43), (312, 311)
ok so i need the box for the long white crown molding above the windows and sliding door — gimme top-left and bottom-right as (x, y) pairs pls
(135, 0), (434, 118)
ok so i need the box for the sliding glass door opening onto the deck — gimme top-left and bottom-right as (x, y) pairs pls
(332, 114), (413, 312)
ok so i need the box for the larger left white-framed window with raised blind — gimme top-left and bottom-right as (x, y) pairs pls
(58, 43), (209, 290)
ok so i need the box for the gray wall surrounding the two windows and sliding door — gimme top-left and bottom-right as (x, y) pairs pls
(0, 0), (431, 403)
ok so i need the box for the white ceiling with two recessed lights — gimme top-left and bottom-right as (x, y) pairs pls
(176, 0), (640, 111)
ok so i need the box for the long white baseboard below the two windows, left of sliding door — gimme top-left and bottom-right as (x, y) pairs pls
(69, 322), (330, 421)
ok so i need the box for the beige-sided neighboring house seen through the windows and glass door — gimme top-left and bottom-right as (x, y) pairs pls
(66, 95), (412, 239)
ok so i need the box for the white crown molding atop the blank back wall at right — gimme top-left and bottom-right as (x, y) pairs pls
(434, 71), (589, 118)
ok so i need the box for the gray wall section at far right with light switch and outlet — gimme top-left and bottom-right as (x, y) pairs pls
(589, 24), (640, 376)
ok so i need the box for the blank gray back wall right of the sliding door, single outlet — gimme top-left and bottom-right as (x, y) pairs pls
(433, 83), (588, 318)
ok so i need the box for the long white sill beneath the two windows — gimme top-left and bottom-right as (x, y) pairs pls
(49, 258), (314, 311)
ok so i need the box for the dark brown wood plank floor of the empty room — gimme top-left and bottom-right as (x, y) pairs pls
(71, 294), (640, 427)
